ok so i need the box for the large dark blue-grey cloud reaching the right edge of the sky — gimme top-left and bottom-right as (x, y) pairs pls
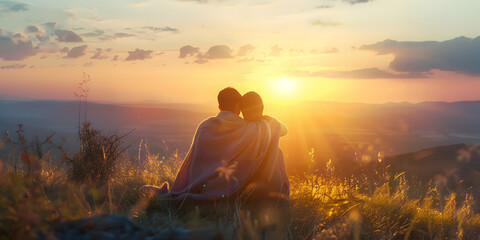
(360, 37), (480, 76)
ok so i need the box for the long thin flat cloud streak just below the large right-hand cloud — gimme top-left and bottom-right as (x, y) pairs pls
(294, 68), (426, 79)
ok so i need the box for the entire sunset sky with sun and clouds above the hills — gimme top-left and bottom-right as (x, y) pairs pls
(0, 0), (480, 103)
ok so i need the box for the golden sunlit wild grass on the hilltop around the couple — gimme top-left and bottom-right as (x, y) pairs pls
(0, 125), (480, 239)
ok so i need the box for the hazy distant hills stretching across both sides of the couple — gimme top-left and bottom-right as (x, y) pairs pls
(0, 96), (480, 182)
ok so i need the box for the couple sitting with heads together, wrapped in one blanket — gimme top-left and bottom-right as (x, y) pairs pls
(148, 87), (289, 207)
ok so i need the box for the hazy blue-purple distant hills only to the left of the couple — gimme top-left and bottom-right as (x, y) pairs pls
(0, 100), (212, 155)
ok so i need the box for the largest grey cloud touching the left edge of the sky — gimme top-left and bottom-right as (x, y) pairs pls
(0, 32), (38, 61)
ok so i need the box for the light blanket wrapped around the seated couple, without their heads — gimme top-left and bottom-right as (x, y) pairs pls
(147, 111), (289, 200)
